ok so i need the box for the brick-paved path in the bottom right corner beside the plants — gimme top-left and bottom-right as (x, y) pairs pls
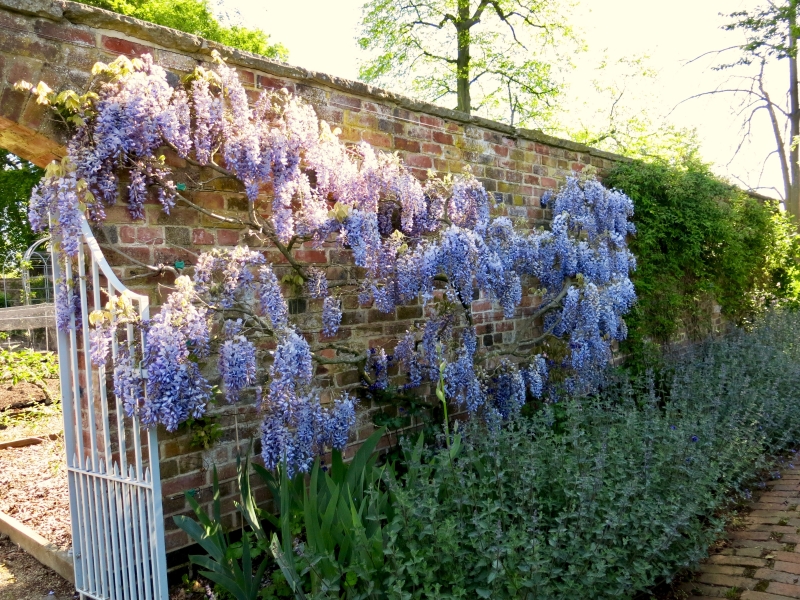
(681, 469), (800, 600)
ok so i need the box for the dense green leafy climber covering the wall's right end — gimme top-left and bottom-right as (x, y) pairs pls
(605, 159), (800, 347)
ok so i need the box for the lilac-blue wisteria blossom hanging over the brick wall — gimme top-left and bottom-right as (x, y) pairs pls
(23, 51), (635, 471)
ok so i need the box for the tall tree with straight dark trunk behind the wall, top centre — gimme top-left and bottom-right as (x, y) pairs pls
(359, 0), (573, 125)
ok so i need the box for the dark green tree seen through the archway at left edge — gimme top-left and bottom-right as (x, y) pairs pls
(0, 150), (44, 260)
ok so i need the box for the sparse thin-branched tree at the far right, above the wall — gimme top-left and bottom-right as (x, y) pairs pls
(693, 0), (800, 218)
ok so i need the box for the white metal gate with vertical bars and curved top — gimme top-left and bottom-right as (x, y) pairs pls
(53, 217), (168, 600)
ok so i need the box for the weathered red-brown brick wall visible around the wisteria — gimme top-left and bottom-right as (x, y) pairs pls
(0, 0), (621, 560)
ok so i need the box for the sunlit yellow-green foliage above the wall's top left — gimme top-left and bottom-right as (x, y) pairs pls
(79, 0), (289, 61)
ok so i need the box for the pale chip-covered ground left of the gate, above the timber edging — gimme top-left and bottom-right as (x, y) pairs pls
(0, 438), (72, 550)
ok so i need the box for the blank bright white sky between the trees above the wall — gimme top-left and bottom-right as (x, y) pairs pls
(219, 0), (786, 202)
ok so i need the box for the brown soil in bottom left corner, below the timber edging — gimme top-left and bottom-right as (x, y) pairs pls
(0, 536), (78, 600)
